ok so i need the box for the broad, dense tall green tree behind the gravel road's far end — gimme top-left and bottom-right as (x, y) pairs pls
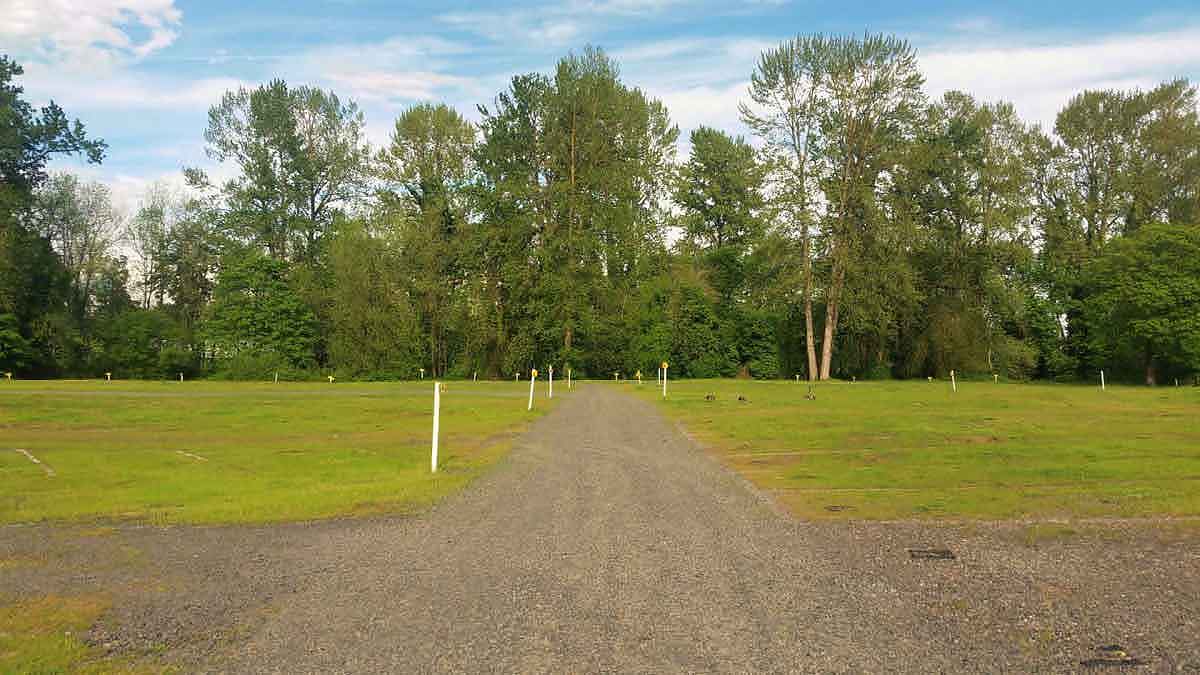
(479, 48), (678, 372)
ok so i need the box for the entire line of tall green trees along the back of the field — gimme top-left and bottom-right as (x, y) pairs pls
(0, 35), (1200, 383)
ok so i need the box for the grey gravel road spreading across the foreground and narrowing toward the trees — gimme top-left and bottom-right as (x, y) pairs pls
(0, 384), (1200, 673)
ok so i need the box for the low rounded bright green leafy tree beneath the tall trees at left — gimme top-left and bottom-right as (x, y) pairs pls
(203, 251), (317, 376)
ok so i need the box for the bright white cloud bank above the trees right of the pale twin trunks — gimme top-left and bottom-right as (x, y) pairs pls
(920, 28), (1200, 129)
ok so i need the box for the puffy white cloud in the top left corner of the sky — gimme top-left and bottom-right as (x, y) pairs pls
(0, 0), (182, 71)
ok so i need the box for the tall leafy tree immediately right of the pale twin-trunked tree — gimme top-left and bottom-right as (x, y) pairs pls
(893, 91), (1033, 375)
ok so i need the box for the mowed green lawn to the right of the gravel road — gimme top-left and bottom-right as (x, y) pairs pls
(640, 381), (1200, 519)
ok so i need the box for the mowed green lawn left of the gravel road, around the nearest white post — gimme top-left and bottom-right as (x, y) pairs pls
(0, 381), (552, 524)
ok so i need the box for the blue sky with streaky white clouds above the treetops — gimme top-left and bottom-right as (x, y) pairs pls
(7, 0), (1200, 209)
